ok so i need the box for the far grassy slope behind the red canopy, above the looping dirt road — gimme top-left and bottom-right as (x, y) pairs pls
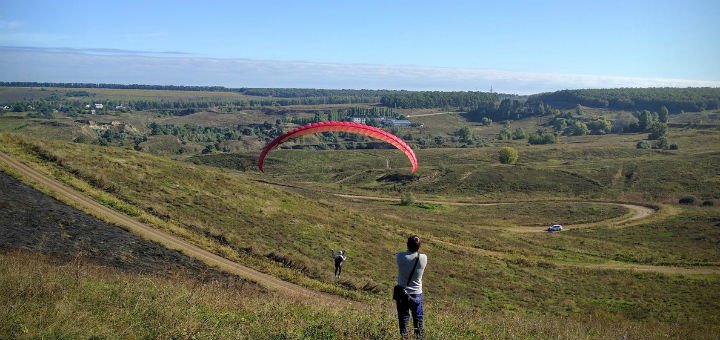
(226, 123), (720, 202)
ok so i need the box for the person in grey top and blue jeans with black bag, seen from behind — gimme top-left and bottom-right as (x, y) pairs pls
(395, 235), (427, 339)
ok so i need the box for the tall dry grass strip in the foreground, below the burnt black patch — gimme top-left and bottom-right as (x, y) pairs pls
(0, 252), (717, 339)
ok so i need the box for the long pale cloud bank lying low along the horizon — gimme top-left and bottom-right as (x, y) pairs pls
(0, 47), (720, 94)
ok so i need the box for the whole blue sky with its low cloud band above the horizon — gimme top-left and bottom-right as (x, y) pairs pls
(0, 0), (720, 94)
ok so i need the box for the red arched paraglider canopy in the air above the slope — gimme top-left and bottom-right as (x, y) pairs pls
(258, 121), (418, 173)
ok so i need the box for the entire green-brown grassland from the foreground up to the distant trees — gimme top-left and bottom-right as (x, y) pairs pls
(0, 89), (720, 339)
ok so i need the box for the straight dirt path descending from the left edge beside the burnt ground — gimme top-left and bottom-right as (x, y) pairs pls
(0, 152), (350, 305)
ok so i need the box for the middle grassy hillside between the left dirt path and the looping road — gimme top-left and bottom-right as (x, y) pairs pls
(2, 135), (720, 332)
